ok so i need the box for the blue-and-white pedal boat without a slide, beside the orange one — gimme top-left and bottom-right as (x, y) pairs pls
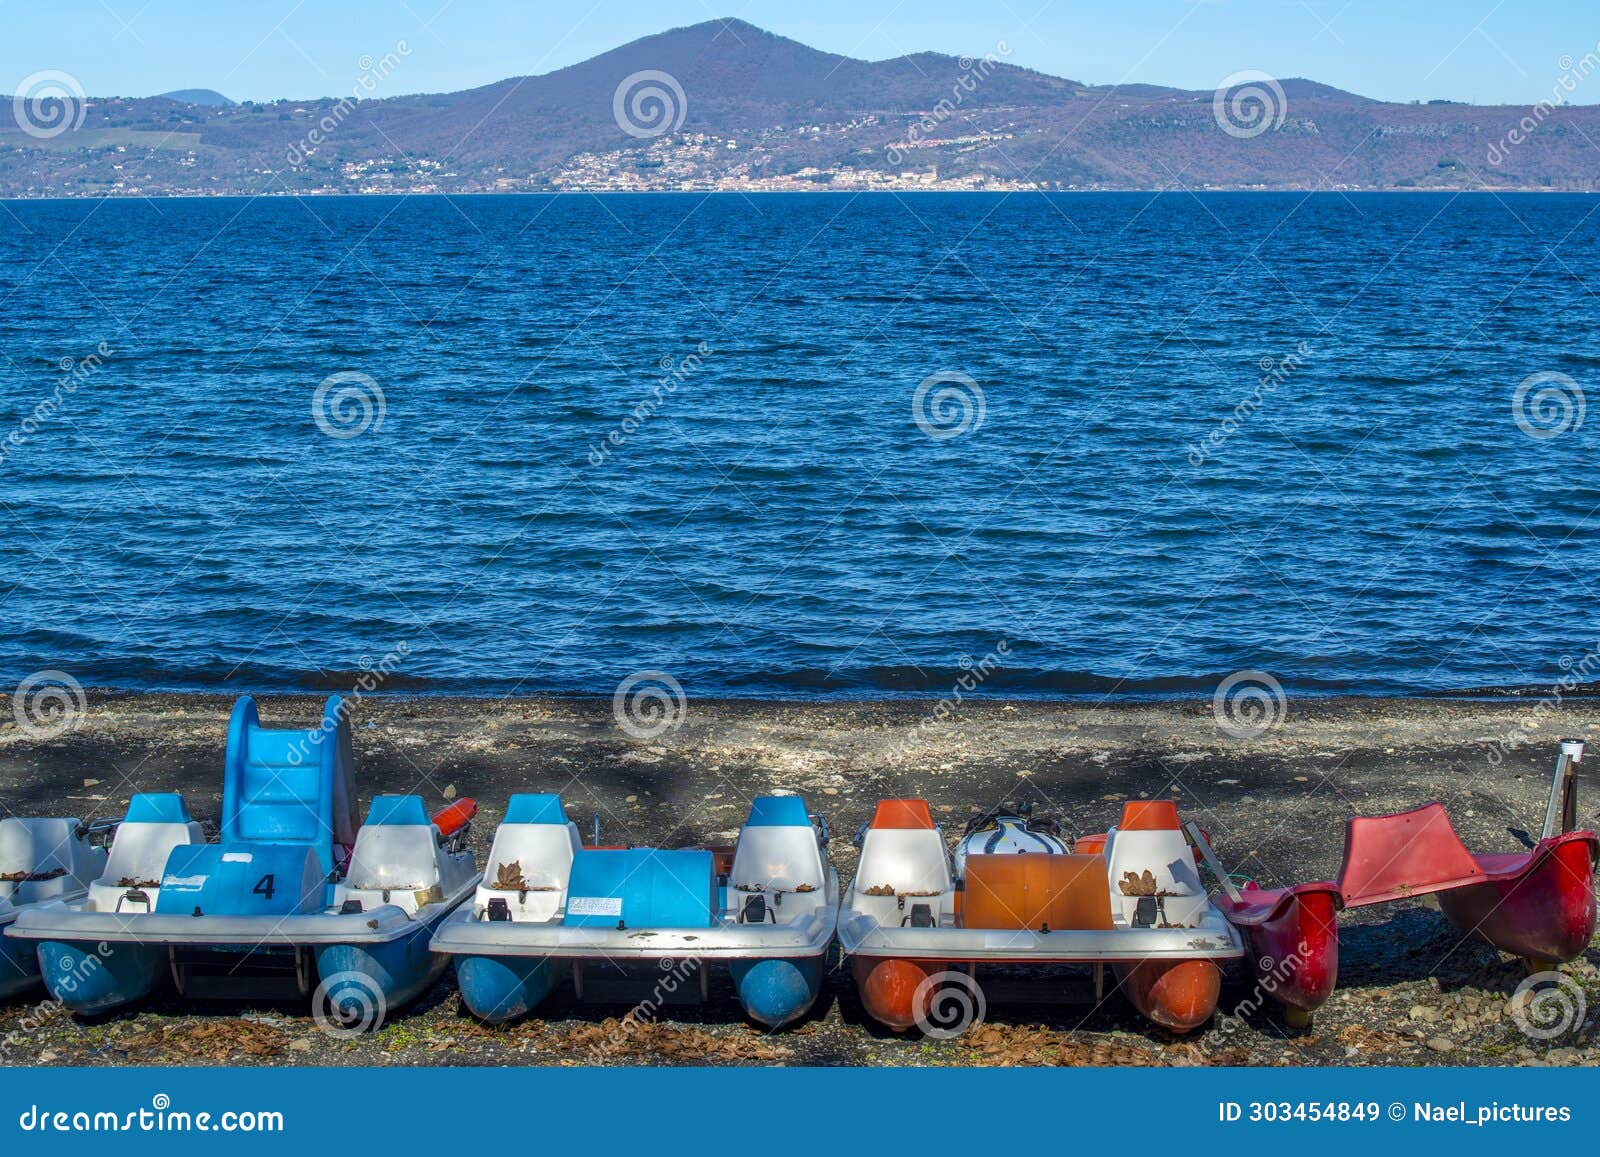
(434, 795), (838, 1027)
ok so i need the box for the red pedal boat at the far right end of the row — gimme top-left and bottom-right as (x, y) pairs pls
(1206, 739), (1600, 1027)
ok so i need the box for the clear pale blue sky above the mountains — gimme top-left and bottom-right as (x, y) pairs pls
(0, 0), (1600, 104)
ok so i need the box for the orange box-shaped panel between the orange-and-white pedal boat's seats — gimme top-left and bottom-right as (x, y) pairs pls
(962, 851), (1114, 931)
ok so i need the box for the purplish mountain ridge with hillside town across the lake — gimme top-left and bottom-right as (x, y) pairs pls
(0, 19), (1600, 197)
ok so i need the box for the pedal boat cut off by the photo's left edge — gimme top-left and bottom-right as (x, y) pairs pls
(0, 816), (112, 1000)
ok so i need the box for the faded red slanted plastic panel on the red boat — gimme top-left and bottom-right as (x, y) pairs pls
(1339, 803), (1483, 907)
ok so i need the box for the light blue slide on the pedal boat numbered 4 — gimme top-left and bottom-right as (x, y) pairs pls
(222, 695), (355, 874)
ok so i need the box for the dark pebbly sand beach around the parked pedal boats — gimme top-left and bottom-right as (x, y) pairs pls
(0, 695), (1600, 1064)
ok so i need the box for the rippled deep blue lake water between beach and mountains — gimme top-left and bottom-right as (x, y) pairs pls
(0, 192), (1600, 696)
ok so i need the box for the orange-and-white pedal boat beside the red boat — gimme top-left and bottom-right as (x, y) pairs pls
(838, 800), (1245, 1032)
